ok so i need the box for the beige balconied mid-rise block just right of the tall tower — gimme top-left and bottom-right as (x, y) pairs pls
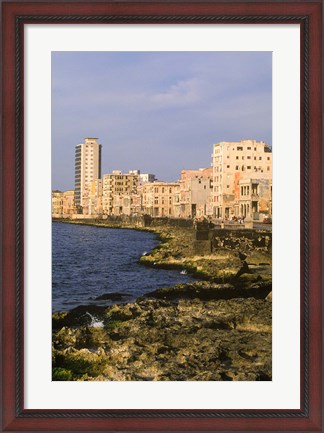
(102, 170), (139, 215)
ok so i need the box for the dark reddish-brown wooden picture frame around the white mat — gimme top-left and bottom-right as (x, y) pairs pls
(1, 0), (324, 432)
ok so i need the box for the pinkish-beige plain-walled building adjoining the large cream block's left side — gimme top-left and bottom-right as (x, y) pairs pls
(179, 168), (213, 218)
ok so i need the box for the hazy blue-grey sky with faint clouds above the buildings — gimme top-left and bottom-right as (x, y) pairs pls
(52, 51), (272, 191)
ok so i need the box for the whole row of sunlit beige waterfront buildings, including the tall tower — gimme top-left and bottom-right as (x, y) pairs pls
(52, 138), (272, 222)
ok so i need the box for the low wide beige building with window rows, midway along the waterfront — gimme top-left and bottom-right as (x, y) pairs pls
(142, 182), (180, 217)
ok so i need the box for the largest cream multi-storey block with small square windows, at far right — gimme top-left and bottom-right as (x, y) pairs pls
(212, 140), (272, 219)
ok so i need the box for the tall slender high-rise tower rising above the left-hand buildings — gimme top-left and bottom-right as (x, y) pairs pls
(74, 137), (101, 210)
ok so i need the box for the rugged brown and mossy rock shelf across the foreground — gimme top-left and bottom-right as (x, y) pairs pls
(53, 298), (271, 381)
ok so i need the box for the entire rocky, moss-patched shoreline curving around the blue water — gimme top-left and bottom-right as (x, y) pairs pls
(52, 220), (272, 381)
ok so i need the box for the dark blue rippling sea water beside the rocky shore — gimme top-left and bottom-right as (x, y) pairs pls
(52, 223), (192, 311)
